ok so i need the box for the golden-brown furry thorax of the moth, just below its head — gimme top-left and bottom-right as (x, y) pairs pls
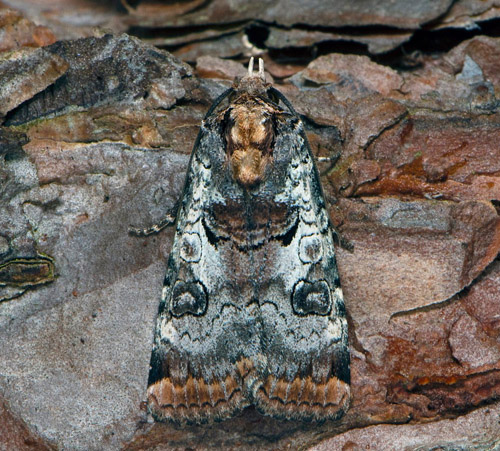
(226, 96), (280, 188)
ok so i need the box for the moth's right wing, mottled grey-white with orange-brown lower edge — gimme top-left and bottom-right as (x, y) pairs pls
(253, 117), (350, 420)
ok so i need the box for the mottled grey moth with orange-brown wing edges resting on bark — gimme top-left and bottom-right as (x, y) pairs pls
(148, 58), (350, 424)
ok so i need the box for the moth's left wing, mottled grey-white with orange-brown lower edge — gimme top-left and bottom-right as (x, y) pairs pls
(148, 118), (254, 423)
